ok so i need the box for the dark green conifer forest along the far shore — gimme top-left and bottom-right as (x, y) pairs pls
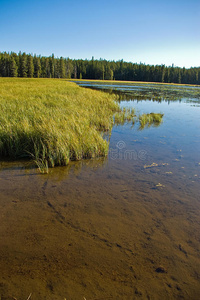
(0, 52), (200, 84)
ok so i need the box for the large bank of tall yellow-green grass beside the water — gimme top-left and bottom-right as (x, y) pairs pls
(0, 78), (118, 167)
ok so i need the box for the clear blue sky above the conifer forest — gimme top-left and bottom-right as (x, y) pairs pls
(0, 0), (200, 68)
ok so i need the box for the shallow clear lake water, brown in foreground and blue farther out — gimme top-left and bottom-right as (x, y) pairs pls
(0, 84), (200, 300)
